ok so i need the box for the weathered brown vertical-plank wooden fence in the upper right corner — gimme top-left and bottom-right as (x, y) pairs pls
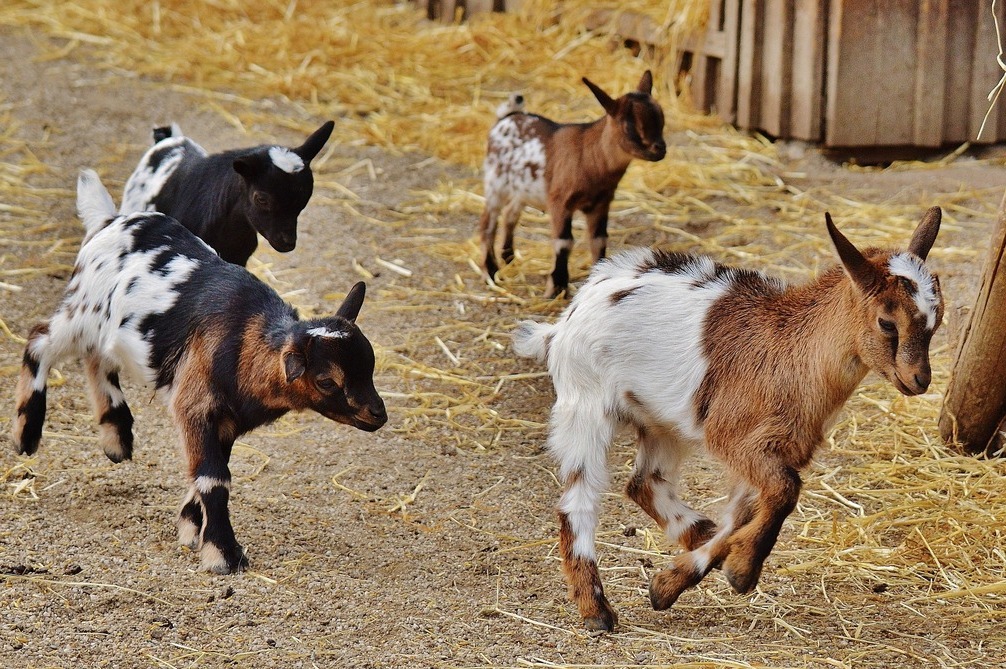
(684, 0), (1006, 147)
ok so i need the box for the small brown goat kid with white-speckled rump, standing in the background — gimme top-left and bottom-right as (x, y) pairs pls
(479, 70), (667, 298)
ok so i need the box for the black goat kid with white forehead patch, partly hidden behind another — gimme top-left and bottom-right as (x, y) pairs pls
(119, 121), (335, 266)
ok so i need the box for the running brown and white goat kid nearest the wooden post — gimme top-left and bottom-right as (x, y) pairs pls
(514, 207), (944, 630)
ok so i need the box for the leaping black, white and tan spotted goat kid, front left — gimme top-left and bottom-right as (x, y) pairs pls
(13, 170), (387, 573)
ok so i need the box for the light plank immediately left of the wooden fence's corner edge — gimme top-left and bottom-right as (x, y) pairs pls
(790, 0), (825, 142)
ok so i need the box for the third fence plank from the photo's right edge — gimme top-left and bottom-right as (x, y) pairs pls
(912, 0), (950, 147)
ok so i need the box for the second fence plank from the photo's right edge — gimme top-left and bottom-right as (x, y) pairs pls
(944, 0), (988, 144)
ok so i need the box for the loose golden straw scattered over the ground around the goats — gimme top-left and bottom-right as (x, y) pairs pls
(0, 0), (1006, 667)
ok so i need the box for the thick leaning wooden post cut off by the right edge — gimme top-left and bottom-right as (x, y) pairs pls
(940, 190), (1006, 454)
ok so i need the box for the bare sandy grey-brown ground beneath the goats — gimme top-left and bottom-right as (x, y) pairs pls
(0, 31), (1006, 668)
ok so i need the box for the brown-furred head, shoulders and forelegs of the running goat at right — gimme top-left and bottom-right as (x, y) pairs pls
(647, 209), (943, 609)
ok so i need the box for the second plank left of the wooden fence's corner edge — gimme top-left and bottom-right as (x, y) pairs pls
(759, 0), (794, 137)
